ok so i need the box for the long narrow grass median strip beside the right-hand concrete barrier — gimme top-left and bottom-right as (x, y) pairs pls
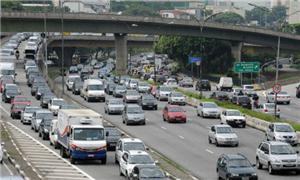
(177, 89), (300, 131)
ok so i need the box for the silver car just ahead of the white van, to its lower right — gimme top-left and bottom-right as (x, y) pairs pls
(104, 98), (124, 114)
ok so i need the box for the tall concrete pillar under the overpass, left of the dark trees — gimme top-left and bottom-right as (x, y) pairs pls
(115, 33), (128, 75)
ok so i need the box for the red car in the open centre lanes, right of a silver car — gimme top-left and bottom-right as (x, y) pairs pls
(163, 105), (186, 123)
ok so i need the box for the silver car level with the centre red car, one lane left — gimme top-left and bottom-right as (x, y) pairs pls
(122, 104), (146, 125)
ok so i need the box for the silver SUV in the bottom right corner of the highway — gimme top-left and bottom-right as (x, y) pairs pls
(256, 141), (300, 174)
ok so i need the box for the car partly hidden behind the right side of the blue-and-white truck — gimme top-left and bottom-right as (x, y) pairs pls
(104, 126), (123, 150)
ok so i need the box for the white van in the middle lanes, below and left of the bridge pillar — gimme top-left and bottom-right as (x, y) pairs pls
(82, 79), (105, 102)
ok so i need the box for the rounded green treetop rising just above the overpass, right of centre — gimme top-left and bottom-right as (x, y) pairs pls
(213, 12), (245, 24)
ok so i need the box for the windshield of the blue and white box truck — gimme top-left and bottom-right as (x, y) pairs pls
(74, 128), (104, 141)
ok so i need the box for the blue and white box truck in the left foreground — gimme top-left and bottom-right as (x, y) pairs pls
(57, 109), (108, 164)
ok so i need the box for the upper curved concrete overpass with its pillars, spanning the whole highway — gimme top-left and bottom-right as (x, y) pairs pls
(1, 12), (300, 72)
